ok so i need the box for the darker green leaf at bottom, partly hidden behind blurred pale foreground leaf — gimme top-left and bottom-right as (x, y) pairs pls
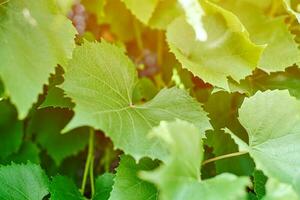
(109, 156), (158, 200)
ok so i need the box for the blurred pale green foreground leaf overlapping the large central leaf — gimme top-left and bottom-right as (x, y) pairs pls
(141, 120), (249, 200)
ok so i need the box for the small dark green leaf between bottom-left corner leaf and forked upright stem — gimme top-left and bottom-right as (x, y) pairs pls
(49, 175), (85, 200)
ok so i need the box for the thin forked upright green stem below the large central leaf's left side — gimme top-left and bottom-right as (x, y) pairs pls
(80, 128), (95, 195)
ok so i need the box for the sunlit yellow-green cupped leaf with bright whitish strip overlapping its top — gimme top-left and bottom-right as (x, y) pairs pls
(167, 1), (263, 90)
